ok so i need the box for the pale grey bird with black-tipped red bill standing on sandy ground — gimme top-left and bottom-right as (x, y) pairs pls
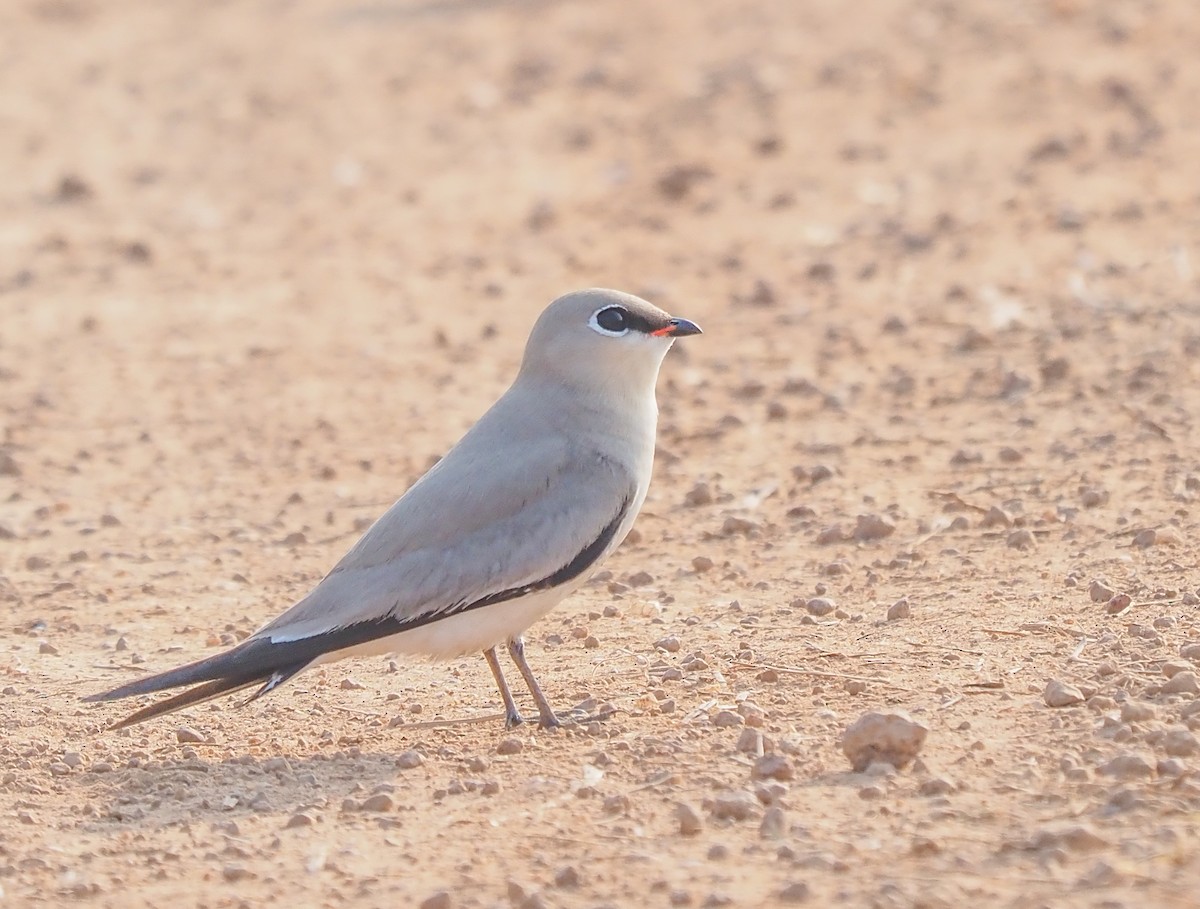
(91, 288), (702, 729)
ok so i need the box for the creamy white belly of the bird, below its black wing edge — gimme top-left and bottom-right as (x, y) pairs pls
(316, 586), (575, 663)
